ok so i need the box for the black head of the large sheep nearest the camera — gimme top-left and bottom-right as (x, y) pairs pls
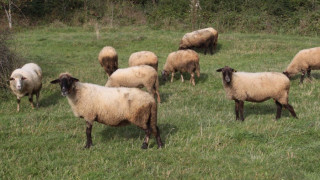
(50, 73), (79, 96)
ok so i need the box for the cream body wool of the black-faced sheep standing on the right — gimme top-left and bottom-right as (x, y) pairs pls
(223, 72), (290, 104)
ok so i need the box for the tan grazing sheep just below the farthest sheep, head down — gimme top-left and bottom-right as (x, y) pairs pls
(162, 49), (200, 85)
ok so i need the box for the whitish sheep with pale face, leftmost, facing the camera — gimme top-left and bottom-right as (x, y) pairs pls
(9, 63), (42, 112)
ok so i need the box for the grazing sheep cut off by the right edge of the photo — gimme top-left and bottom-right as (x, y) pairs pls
(283, 47), (320, 84)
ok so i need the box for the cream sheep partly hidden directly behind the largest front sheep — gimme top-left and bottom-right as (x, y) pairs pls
(105, 65), (161, 103)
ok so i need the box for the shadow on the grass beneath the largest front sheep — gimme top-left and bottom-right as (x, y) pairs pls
(100, 124), (178, 148)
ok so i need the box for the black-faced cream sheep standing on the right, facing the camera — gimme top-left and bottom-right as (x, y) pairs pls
(217, 66), (297, 121)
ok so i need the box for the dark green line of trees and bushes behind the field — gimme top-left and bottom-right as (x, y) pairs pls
(0, 0), (320, 35)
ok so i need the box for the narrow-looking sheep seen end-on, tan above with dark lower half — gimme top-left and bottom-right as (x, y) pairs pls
(98, 46), (118, 77)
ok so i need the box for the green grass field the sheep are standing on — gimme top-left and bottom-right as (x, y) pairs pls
(0, 27), (320, 179)
